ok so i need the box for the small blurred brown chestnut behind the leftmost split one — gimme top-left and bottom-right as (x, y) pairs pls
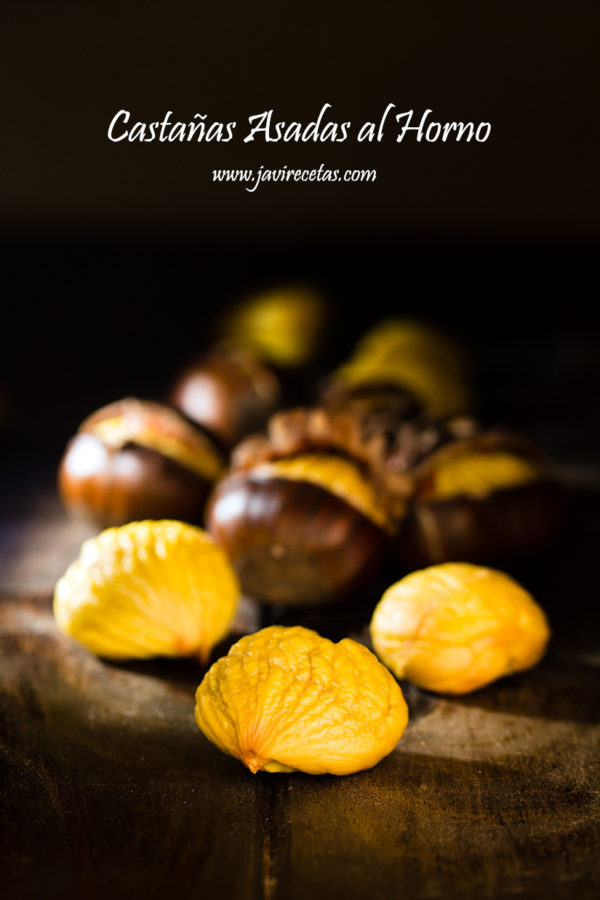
(170, 346), (281, 447)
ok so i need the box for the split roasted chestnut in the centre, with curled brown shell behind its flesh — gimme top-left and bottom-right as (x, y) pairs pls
(206, 409), (408, 605)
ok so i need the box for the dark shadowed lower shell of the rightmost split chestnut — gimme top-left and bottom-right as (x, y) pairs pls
(394, 479), (563, 569)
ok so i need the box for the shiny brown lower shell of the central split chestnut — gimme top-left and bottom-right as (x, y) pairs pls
(206, 470), (387, 606)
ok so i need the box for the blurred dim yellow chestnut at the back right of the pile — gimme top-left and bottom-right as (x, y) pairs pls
(325, 319), (472, 419)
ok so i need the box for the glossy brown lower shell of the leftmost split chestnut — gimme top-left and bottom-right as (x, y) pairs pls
(58, 432), (211, 527)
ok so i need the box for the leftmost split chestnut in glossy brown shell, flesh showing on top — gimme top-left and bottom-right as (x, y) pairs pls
(58, 398), (223, 526)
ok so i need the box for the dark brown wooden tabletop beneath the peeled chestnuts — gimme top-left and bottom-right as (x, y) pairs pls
(0, 474), (600, 900)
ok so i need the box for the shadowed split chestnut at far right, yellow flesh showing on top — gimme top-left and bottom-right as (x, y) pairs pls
(395, 431), (562, 569)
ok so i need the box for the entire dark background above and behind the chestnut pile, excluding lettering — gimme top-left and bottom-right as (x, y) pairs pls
(0, 0), (600, 472)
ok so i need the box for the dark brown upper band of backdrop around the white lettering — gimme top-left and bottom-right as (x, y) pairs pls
(0, 0), (600, 238)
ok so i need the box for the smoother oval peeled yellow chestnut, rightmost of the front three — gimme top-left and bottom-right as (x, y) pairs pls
(371, 563), (550, 694)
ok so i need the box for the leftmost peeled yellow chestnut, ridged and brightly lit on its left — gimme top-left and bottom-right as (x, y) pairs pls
(54, 520), (239, 661)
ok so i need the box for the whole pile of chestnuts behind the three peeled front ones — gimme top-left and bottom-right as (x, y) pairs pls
(59, 291), (561, 606)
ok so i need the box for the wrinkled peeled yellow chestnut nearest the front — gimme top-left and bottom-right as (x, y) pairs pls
(195, 626), (408, 775)
